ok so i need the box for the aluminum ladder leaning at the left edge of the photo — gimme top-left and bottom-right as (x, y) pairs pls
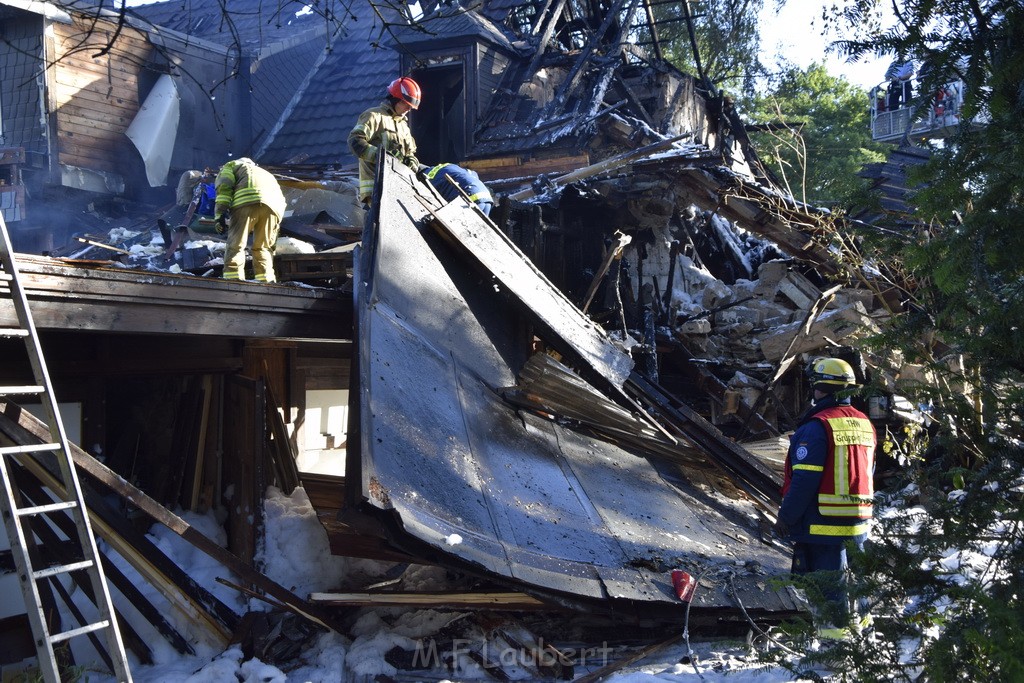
(0, 214), (131, 683)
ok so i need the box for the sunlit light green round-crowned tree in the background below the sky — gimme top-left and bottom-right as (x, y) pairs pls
(744, 63), (884, 206)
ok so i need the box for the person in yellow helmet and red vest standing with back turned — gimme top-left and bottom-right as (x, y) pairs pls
(775, 358), (877, 616)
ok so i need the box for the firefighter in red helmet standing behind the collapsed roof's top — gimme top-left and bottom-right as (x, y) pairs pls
(348, 76), (422, 205)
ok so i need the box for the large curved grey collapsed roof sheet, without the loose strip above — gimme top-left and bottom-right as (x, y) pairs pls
(350, 157), (797, 612)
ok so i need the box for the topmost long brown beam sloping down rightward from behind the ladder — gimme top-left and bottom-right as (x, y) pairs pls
(0, 400), (345, 642)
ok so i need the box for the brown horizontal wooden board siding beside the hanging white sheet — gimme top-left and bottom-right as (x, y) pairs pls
(49, 19), (153, 173)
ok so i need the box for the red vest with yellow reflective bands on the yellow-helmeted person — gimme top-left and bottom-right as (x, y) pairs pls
(814, 405), (878, 519)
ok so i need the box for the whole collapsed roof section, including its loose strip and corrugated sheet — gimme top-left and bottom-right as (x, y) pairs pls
(348, 161), (800, 621)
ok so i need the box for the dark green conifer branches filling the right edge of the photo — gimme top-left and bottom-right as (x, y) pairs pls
(765, 0), (1024, 681)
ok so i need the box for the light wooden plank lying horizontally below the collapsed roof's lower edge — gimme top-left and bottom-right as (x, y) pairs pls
(309, 591), (562, 611)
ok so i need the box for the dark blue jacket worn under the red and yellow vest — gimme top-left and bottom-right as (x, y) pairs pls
(778, 396), (873, 545)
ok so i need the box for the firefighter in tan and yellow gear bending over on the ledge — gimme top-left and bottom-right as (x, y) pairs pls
(216, 157), (288, 283)
